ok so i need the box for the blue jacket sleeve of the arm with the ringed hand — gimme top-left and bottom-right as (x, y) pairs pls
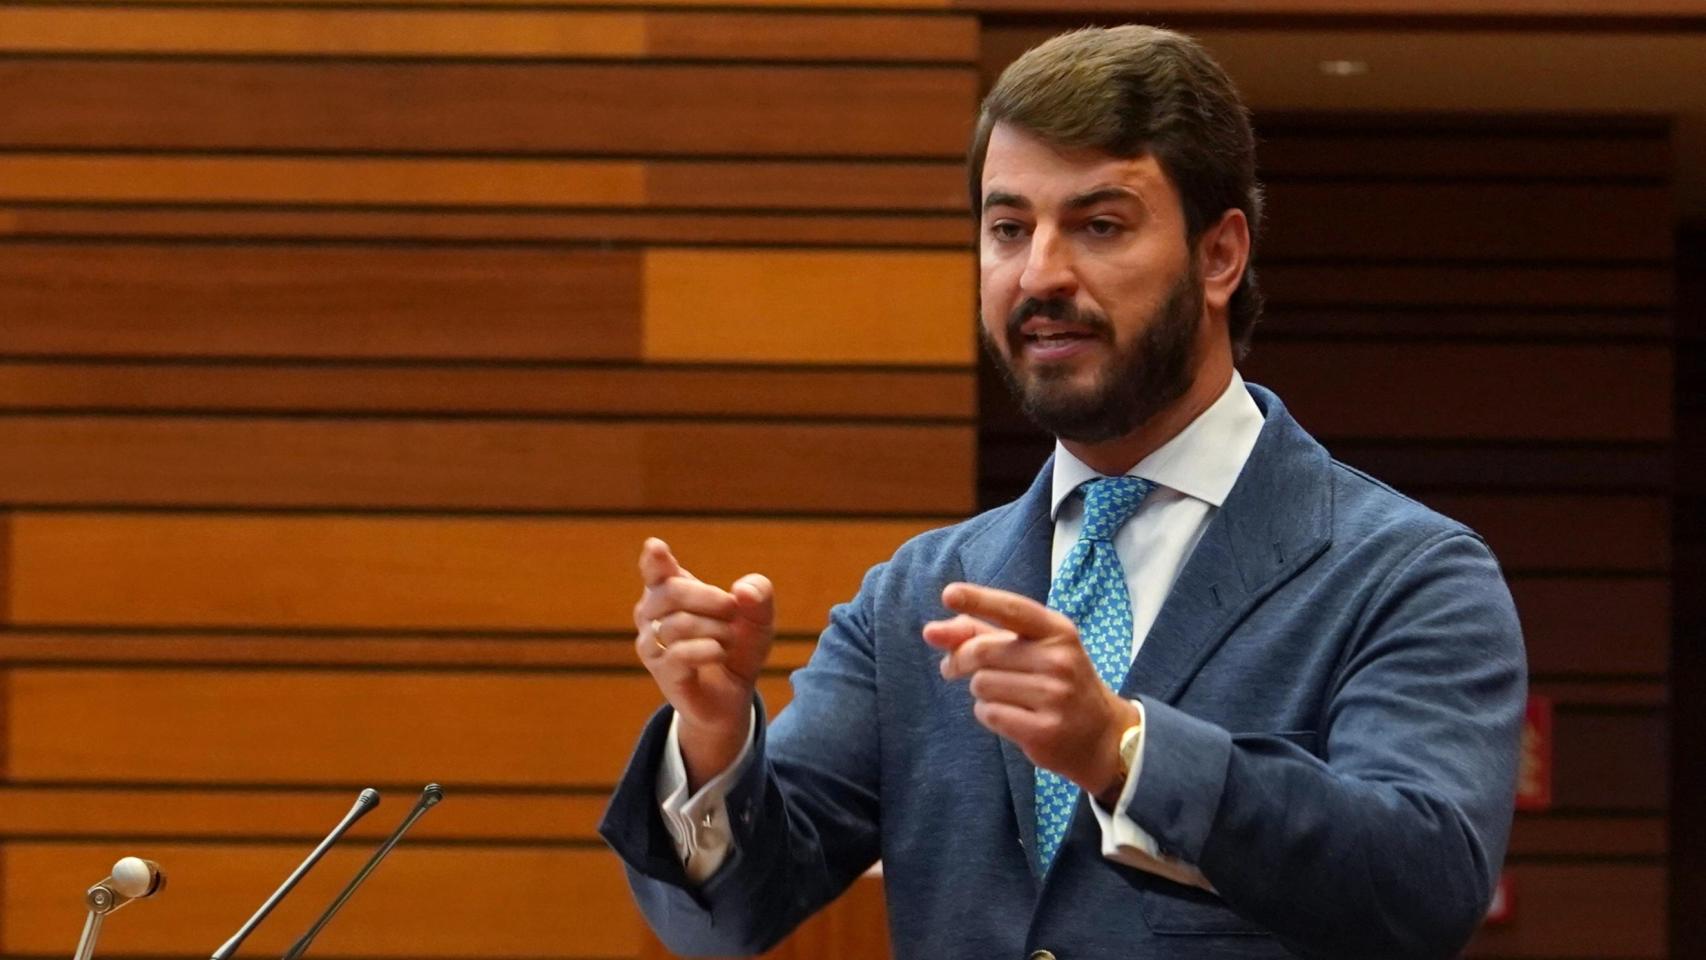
(599, 566), (884, 955)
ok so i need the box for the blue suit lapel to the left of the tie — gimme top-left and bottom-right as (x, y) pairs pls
(960, 457), (1054, 878)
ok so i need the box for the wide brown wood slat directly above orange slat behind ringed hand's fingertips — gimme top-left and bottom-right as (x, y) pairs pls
(0, 416), (976, 515)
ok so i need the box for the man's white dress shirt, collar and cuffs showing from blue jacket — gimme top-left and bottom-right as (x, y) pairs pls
(657, 372), (1262, 887)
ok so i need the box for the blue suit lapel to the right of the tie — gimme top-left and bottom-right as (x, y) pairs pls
(1121, 385), (1332, 703)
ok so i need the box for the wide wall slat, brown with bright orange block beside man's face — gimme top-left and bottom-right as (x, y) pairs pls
(0, 244), (974, 365)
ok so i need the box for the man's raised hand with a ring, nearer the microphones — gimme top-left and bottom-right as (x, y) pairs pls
(635, 537), (776, 789)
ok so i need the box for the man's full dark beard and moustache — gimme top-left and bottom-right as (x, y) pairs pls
(979, 269), (1203, 443)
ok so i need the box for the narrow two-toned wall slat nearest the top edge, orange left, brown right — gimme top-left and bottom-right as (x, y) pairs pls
(0, 5), (978, 63)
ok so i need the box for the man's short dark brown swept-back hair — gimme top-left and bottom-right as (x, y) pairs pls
(967, 26), (1262, 358)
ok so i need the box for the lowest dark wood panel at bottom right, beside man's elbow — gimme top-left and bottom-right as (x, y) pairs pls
(1469, 863), (1667, 960)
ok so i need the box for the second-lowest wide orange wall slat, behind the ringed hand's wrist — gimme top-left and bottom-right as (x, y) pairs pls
(5, 667), (790, 789)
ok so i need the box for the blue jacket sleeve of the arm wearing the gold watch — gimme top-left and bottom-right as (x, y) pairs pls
(1128, 530), (1527, 960)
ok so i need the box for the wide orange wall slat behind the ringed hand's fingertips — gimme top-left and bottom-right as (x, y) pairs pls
(10, 513), (940, 634)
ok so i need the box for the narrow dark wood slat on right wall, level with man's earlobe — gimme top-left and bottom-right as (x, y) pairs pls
(1259, 263), (1672, 310)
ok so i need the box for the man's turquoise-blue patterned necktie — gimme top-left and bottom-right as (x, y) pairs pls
(1037, 477), (1155, 873)
